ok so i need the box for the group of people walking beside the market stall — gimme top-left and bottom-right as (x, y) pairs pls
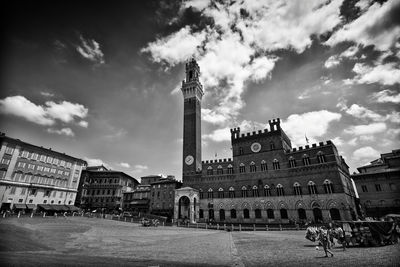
(306, 225), (346, 257)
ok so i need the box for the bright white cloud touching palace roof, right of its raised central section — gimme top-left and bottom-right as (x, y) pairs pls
(282, 110), (342, 146)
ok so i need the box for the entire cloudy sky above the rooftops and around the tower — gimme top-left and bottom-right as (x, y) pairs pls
(0, 0), (400, 179)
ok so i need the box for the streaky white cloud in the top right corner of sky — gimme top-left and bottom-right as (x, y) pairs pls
(326, 0), (400, 51)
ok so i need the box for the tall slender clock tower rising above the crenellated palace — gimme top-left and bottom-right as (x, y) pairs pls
(181, 58), (204, 181)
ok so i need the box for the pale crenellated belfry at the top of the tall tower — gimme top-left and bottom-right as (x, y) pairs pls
(181, 57), (204, 101)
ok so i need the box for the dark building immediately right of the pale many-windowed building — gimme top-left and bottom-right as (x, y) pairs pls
(80, 166), (139, 212)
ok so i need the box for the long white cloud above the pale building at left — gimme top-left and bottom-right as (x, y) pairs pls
(0, 96), (88, 130)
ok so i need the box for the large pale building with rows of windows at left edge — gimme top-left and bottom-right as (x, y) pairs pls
(0, 133), (87, 214)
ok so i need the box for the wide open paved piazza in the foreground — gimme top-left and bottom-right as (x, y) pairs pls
(0, 217), (400, 266)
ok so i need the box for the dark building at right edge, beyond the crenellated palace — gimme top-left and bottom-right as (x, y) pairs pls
(351, 149), (400, 218)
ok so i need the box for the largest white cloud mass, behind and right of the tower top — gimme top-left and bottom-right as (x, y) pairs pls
(141, 0), (342, 127)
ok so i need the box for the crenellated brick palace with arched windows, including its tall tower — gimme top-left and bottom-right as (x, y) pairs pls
(175, 60), (356, 223)
